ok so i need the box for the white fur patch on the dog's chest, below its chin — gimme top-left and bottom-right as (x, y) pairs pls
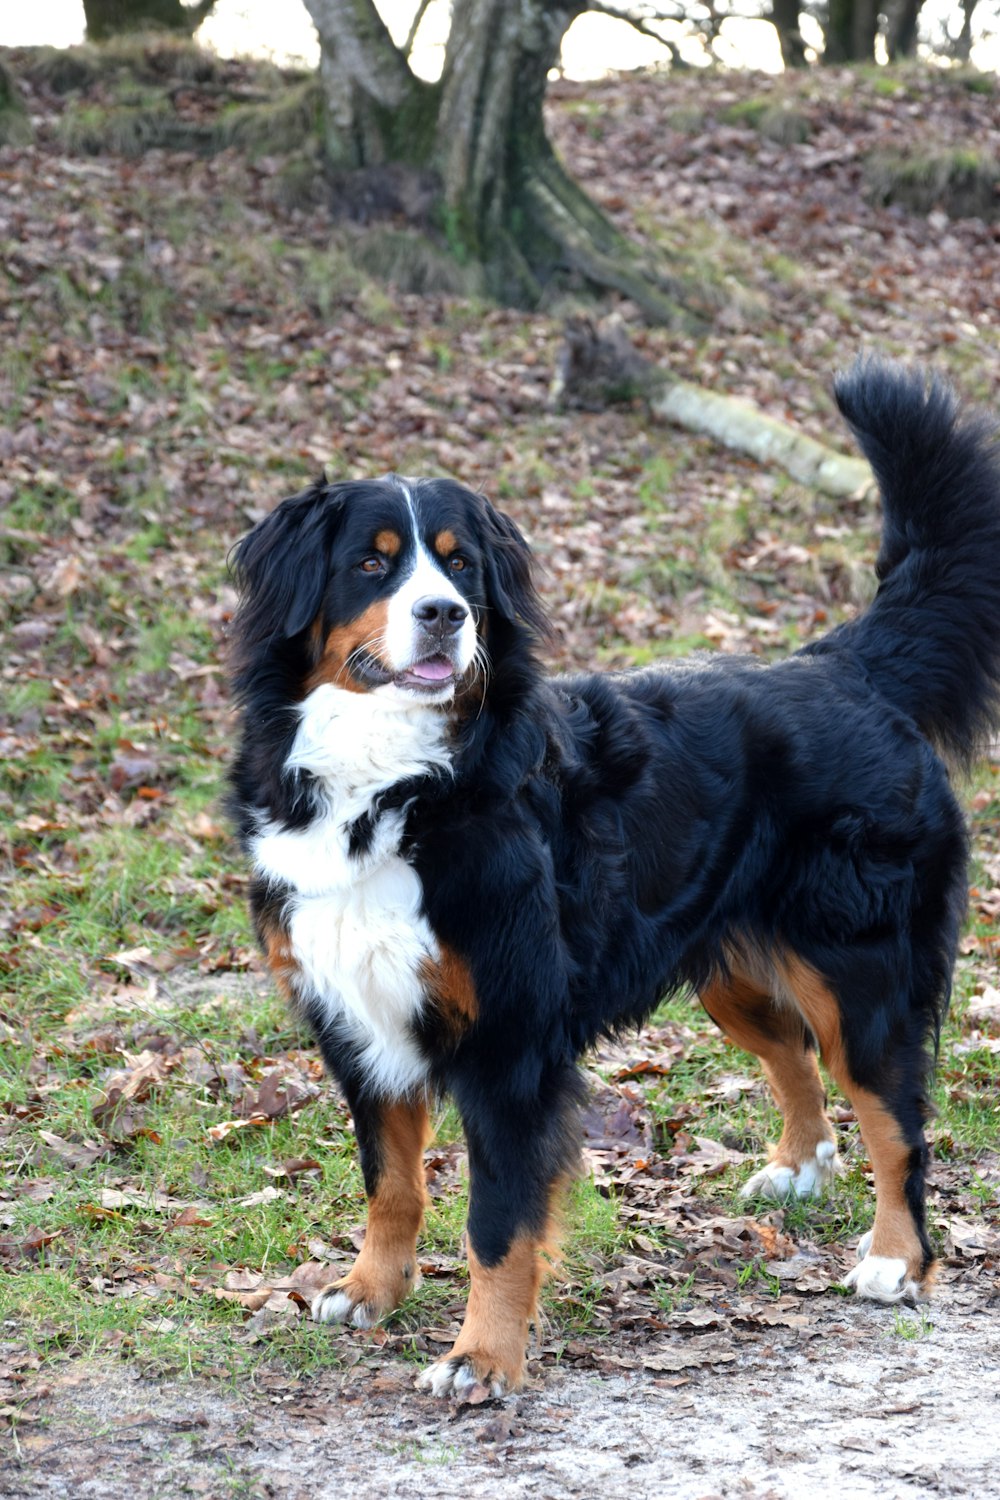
(252, 684), (450, 1097)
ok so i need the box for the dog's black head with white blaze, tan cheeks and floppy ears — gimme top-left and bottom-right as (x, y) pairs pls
(232, 474), (546, 704)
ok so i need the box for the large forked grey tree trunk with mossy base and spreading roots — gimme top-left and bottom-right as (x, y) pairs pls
(296, 0), (689, 321)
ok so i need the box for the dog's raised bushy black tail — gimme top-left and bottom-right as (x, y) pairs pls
(834, 359), (1000, 765)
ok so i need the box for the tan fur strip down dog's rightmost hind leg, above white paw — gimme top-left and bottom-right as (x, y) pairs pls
(780, 954), (924, 1286)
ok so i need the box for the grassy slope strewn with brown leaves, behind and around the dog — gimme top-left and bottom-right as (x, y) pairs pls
(0, 43), (1000, 1371)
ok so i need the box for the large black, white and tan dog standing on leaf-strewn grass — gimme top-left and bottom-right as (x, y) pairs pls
(232, 362), (1000, 1395)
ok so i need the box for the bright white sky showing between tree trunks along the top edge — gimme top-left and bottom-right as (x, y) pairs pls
(0, 0), (1000, 80)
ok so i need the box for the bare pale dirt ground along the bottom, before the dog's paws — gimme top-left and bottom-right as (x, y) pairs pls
(7, 1287), (1000, 1500)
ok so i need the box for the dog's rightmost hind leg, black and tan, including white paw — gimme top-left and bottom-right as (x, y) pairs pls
(781, 956), (934, 1302)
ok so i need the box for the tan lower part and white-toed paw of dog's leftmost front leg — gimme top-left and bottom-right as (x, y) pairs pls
(312, 1098), (430, 1328)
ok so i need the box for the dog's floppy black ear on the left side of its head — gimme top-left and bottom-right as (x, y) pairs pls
(229, 480), (343, 650)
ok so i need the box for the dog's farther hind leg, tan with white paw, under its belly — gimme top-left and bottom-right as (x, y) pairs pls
(700, 972), (840, 1200)
